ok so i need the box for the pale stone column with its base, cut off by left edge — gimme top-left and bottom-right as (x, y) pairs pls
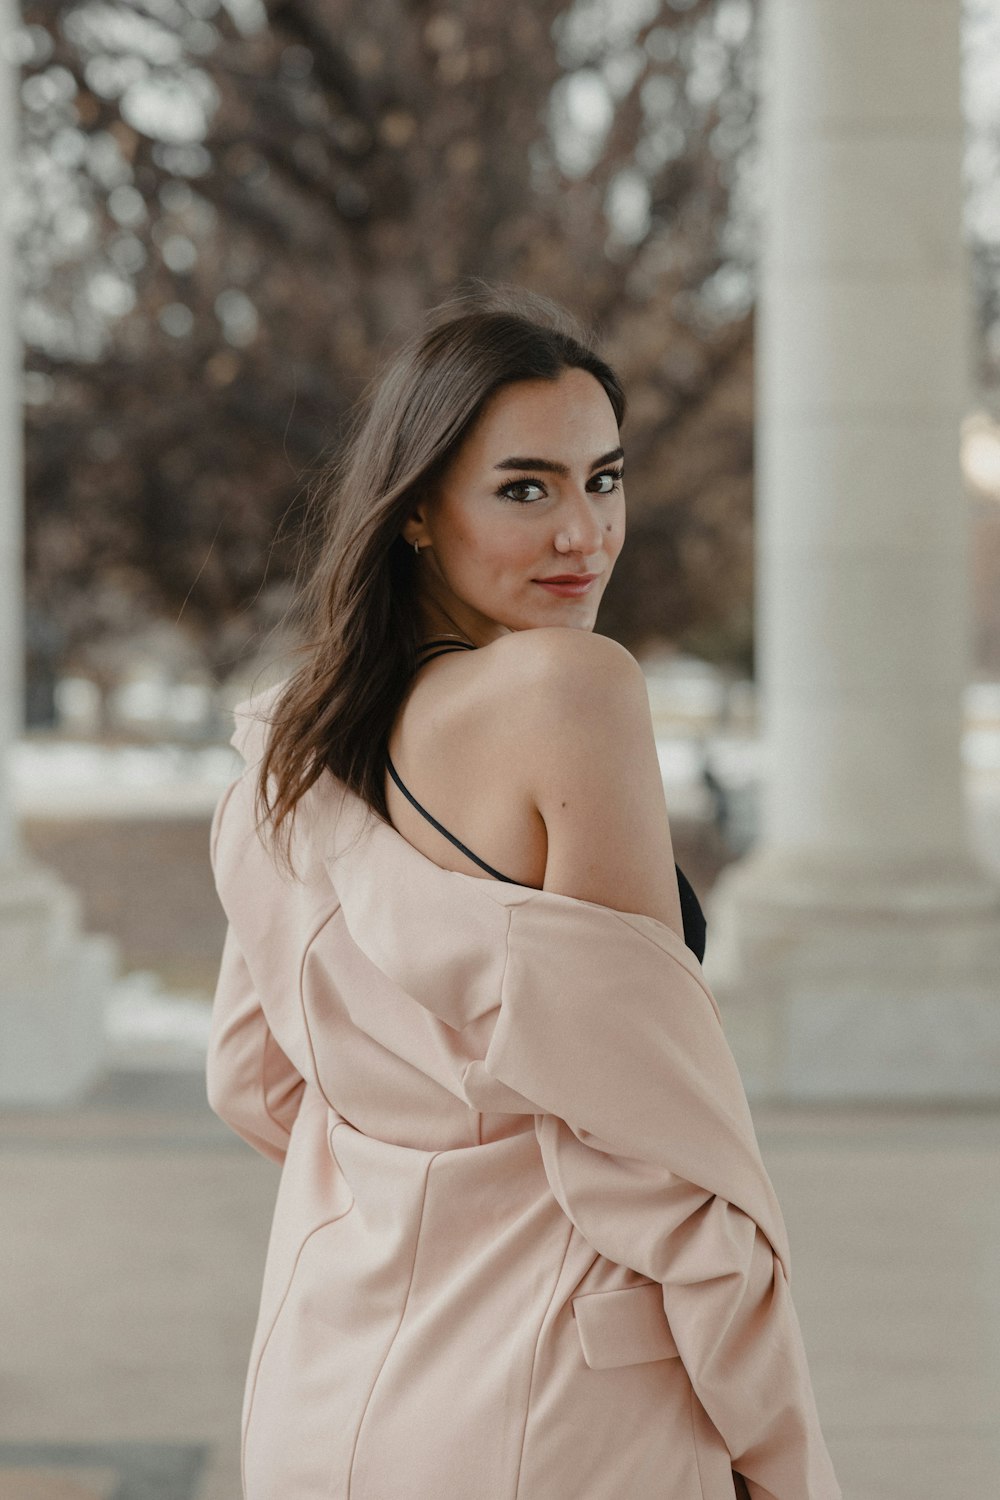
(0, 0), (114, 1104)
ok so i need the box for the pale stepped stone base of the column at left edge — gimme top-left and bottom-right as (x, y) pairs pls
(0, 863), (117, 1106)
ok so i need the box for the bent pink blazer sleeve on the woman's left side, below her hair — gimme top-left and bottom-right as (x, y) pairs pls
(205, 783), (306, 1164)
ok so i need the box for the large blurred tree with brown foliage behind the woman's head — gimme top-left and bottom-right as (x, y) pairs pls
(18, 0), (996, 702)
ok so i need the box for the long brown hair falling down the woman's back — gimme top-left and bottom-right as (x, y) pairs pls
(256, 287), (625, 861)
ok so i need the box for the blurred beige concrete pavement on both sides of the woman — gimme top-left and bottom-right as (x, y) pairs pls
(0, 1073), (1000, 1500)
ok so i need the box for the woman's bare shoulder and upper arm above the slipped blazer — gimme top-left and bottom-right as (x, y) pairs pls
(487, 627), (684, 936)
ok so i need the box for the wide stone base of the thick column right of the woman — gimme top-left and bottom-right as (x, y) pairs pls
(703, 849), (1000, 1103)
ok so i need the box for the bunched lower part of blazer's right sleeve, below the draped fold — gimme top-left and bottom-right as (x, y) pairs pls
(535, 1101), (841, 1500)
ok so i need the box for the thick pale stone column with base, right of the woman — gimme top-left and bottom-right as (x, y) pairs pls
(705, 0), (1000, 1100)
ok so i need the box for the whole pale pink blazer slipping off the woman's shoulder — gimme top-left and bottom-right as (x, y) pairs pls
(208, 689), (841, 1500)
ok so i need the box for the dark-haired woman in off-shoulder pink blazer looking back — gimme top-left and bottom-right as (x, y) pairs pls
(208, 286), (840, 1500)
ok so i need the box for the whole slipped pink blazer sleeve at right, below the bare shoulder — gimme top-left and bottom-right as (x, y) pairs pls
(484, 909), (841, 1500)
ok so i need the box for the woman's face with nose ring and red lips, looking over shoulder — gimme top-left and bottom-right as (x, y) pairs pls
(403, 369), (625, 645)
